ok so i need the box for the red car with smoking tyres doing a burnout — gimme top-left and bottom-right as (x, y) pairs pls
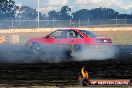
(26, 29), (115, 57)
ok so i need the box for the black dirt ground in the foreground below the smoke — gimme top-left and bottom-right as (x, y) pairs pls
(0, 58), (132, 86)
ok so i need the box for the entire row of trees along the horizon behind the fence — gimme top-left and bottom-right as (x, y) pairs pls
(0, 0), (132, 20)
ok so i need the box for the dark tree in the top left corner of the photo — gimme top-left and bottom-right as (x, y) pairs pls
(0, 0), (16, 20)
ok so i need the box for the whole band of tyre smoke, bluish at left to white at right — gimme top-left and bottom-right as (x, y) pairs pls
(0, 45), (119, 63)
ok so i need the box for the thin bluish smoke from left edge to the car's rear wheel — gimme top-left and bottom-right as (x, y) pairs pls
(0, 45), (70, 63)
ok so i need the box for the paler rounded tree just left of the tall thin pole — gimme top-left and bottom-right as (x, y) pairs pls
(17, 6), (38, 20)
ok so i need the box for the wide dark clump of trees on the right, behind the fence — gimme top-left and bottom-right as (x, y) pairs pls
(72, 7), (119, 20)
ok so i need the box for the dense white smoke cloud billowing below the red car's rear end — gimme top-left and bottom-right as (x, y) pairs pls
(72, 46), (119, 60)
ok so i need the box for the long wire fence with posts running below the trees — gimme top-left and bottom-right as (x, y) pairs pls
(0, 19), (132, 29)
